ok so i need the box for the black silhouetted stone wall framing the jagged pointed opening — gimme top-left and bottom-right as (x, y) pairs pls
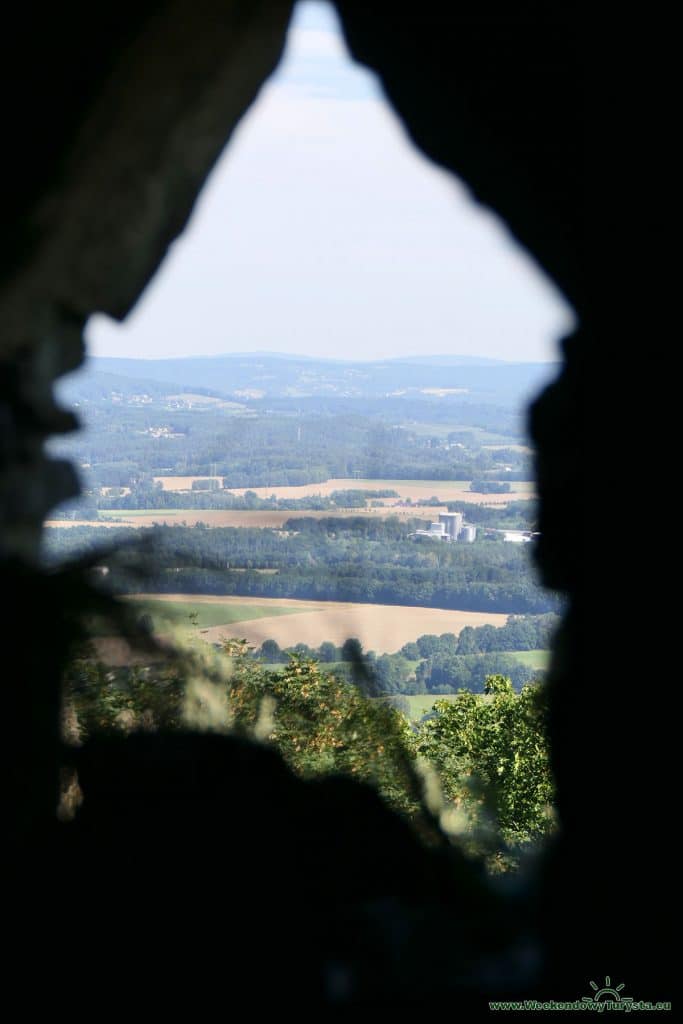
(0, 0), (676, 1016)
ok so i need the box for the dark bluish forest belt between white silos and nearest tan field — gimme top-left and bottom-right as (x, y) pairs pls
(46, 516), (559, 613)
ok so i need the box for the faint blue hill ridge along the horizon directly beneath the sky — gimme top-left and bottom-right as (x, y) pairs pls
(68, 353), (554, 407)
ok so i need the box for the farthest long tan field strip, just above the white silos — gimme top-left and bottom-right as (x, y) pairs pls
(150, 476), (533, 505)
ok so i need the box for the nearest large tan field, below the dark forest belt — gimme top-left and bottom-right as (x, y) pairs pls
(129, 594), (508, 653)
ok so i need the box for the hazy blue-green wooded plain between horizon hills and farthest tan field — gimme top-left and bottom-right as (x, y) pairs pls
(53, 404), (530, 488)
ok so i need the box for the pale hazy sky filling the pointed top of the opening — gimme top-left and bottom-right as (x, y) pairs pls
(87, 2), (571, 360)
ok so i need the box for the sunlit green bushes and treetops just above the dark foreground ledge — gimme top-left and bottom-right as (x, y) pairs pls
(65, 626), (553, 867)
